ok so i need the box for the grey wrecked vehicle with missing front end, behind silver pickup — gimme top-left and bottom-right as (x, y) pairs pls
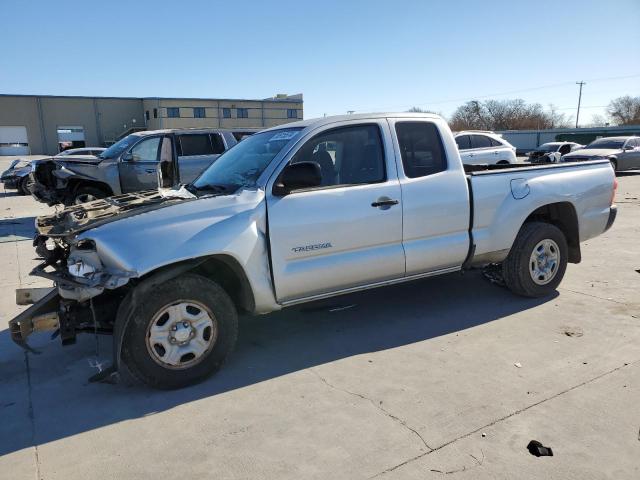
(29, 129), (238, 206)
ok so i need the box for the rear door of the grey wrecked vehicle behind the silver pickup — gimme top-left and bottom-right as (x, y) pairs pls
(177, 133), (224, 183)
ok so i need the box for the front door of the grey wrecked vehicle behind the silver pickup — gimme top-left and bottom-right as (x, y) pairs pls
(118, 136), (162, 193)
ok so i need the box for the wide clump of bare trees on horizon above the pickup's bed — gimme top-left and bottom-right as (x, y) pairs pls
(449, 98), (568, 130)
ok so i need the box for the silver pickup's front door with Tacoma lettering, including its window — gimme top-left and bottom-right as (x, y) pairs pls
(267, 121), (404, 303)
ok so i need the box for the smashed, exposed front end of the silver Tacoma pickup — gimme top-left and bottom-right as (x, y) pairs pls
(9, 191), (175, 350)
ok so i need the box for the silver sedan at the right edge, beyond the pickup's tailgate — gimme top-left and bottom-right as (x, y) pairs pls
(562, 136), (640, 172)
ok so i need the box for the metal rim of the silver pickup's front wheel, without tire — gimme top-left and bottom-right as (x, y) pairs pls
(145, 300), (218, 370)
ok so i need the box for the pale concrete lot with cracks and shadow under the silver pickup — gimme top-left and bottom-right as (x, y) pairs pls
(0, 156), (640, 480)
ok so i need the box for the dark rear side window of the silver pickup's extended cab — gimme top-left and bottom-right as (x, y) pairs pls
(396, 122), (447, 178)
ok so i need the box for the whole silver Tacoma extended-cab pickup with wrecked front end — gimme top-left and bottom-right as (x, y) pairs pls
(9, 113), (616, 388)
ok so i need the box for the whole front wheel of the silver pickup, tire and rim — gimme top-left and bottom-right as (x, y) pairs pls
(122, 274), (238, 389)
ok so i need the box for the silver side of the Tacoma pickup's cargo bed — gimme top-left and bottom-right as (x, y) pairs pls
(465, 160), (615, 264)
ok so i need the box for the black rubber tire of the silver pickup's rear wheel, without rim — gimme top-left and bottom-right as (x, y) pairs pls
(502, 222), (569, 298)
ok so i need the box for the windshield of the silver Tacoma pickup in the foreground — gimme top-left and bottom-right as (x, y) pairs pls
(190, 128), (302, 191)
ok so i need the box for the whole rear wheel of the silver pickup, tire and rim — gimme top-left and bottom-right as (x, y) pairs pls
(502, 222), (569, 298)
